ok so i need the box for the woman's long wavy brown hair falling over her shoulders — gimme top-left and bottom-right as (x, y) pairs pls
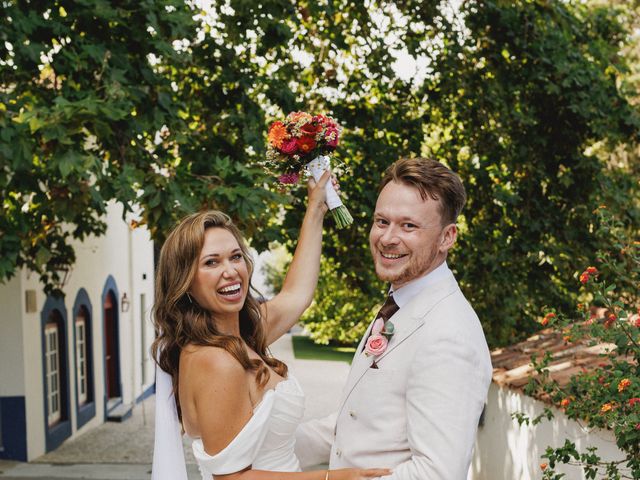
(151, 210), (287, 419)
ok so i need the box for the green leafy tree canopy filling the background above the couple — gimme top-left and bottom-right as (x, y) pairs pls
(0, 0), (639, 344)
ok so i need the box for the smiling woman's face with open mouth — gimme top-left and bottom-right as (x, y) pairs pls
(189, 228), (249, 321)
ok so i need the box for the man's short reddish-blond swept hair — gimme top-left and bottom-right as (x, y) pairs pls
(380, 157), (467, 225)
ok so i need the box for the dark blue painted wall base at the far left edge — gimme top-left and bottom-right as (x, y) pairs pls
(0, 397), (27, 462)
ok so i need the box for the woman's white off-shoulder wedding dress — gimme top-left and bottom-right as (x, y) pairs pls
(192, 375), (304, 480)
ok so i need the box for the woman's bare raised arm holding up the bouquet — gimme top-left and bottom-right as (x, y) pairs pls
(261, 171), (331, 345)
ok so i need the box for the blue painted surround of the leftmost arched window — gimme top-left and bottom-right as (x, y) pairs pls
(40, 296), (71, 452)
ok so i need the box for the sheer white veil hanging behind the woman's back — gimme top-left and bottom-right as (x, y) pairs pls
(151, 366), (187, 480)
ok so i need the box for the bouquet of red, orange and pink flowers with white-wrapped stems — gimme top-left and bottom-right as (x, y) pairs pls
(266, 112), (353, 228)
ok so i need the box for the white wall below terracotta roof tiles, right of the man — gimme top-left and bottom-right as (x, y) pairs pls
(469, 383), (624, 480)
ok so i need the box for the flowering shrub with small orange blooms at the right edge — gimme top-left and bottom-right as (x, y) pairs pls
(513, 206), (640, 480)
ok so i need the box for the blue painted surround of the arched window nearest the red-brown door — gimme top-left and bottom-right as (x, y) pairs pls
(72, 288), (96, 429)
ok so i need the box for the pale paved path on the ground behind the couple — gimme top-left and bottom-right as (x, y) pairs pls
(0, 335), (349, 480)
